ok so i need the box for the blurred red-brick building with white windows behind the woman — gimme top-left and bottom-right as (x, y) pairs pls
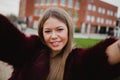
(19, 0), (117, 33)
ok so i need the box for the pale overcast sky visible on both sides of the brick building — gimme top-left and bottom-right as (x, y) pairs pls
(0, 0), (120, 17)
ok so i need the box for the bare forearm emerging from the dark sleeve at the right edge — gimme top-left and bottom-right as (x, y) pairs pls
(106, 40), (120, 65)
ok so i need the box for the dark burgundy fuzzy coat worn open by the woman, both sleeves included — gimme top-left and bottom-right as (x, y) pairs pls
(0, 15), (120, 80)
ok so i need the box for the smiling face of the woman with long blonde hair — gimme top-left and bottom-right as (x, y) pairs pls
(43, 17), (68, 53)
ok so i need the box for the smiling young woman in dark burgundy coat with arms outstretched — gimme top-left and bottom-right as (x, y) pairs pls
(0, 8), (120, 80)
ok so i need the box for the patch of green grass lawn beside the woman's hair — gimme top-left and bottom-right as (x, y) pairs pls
(74, 38), (102, 48)
